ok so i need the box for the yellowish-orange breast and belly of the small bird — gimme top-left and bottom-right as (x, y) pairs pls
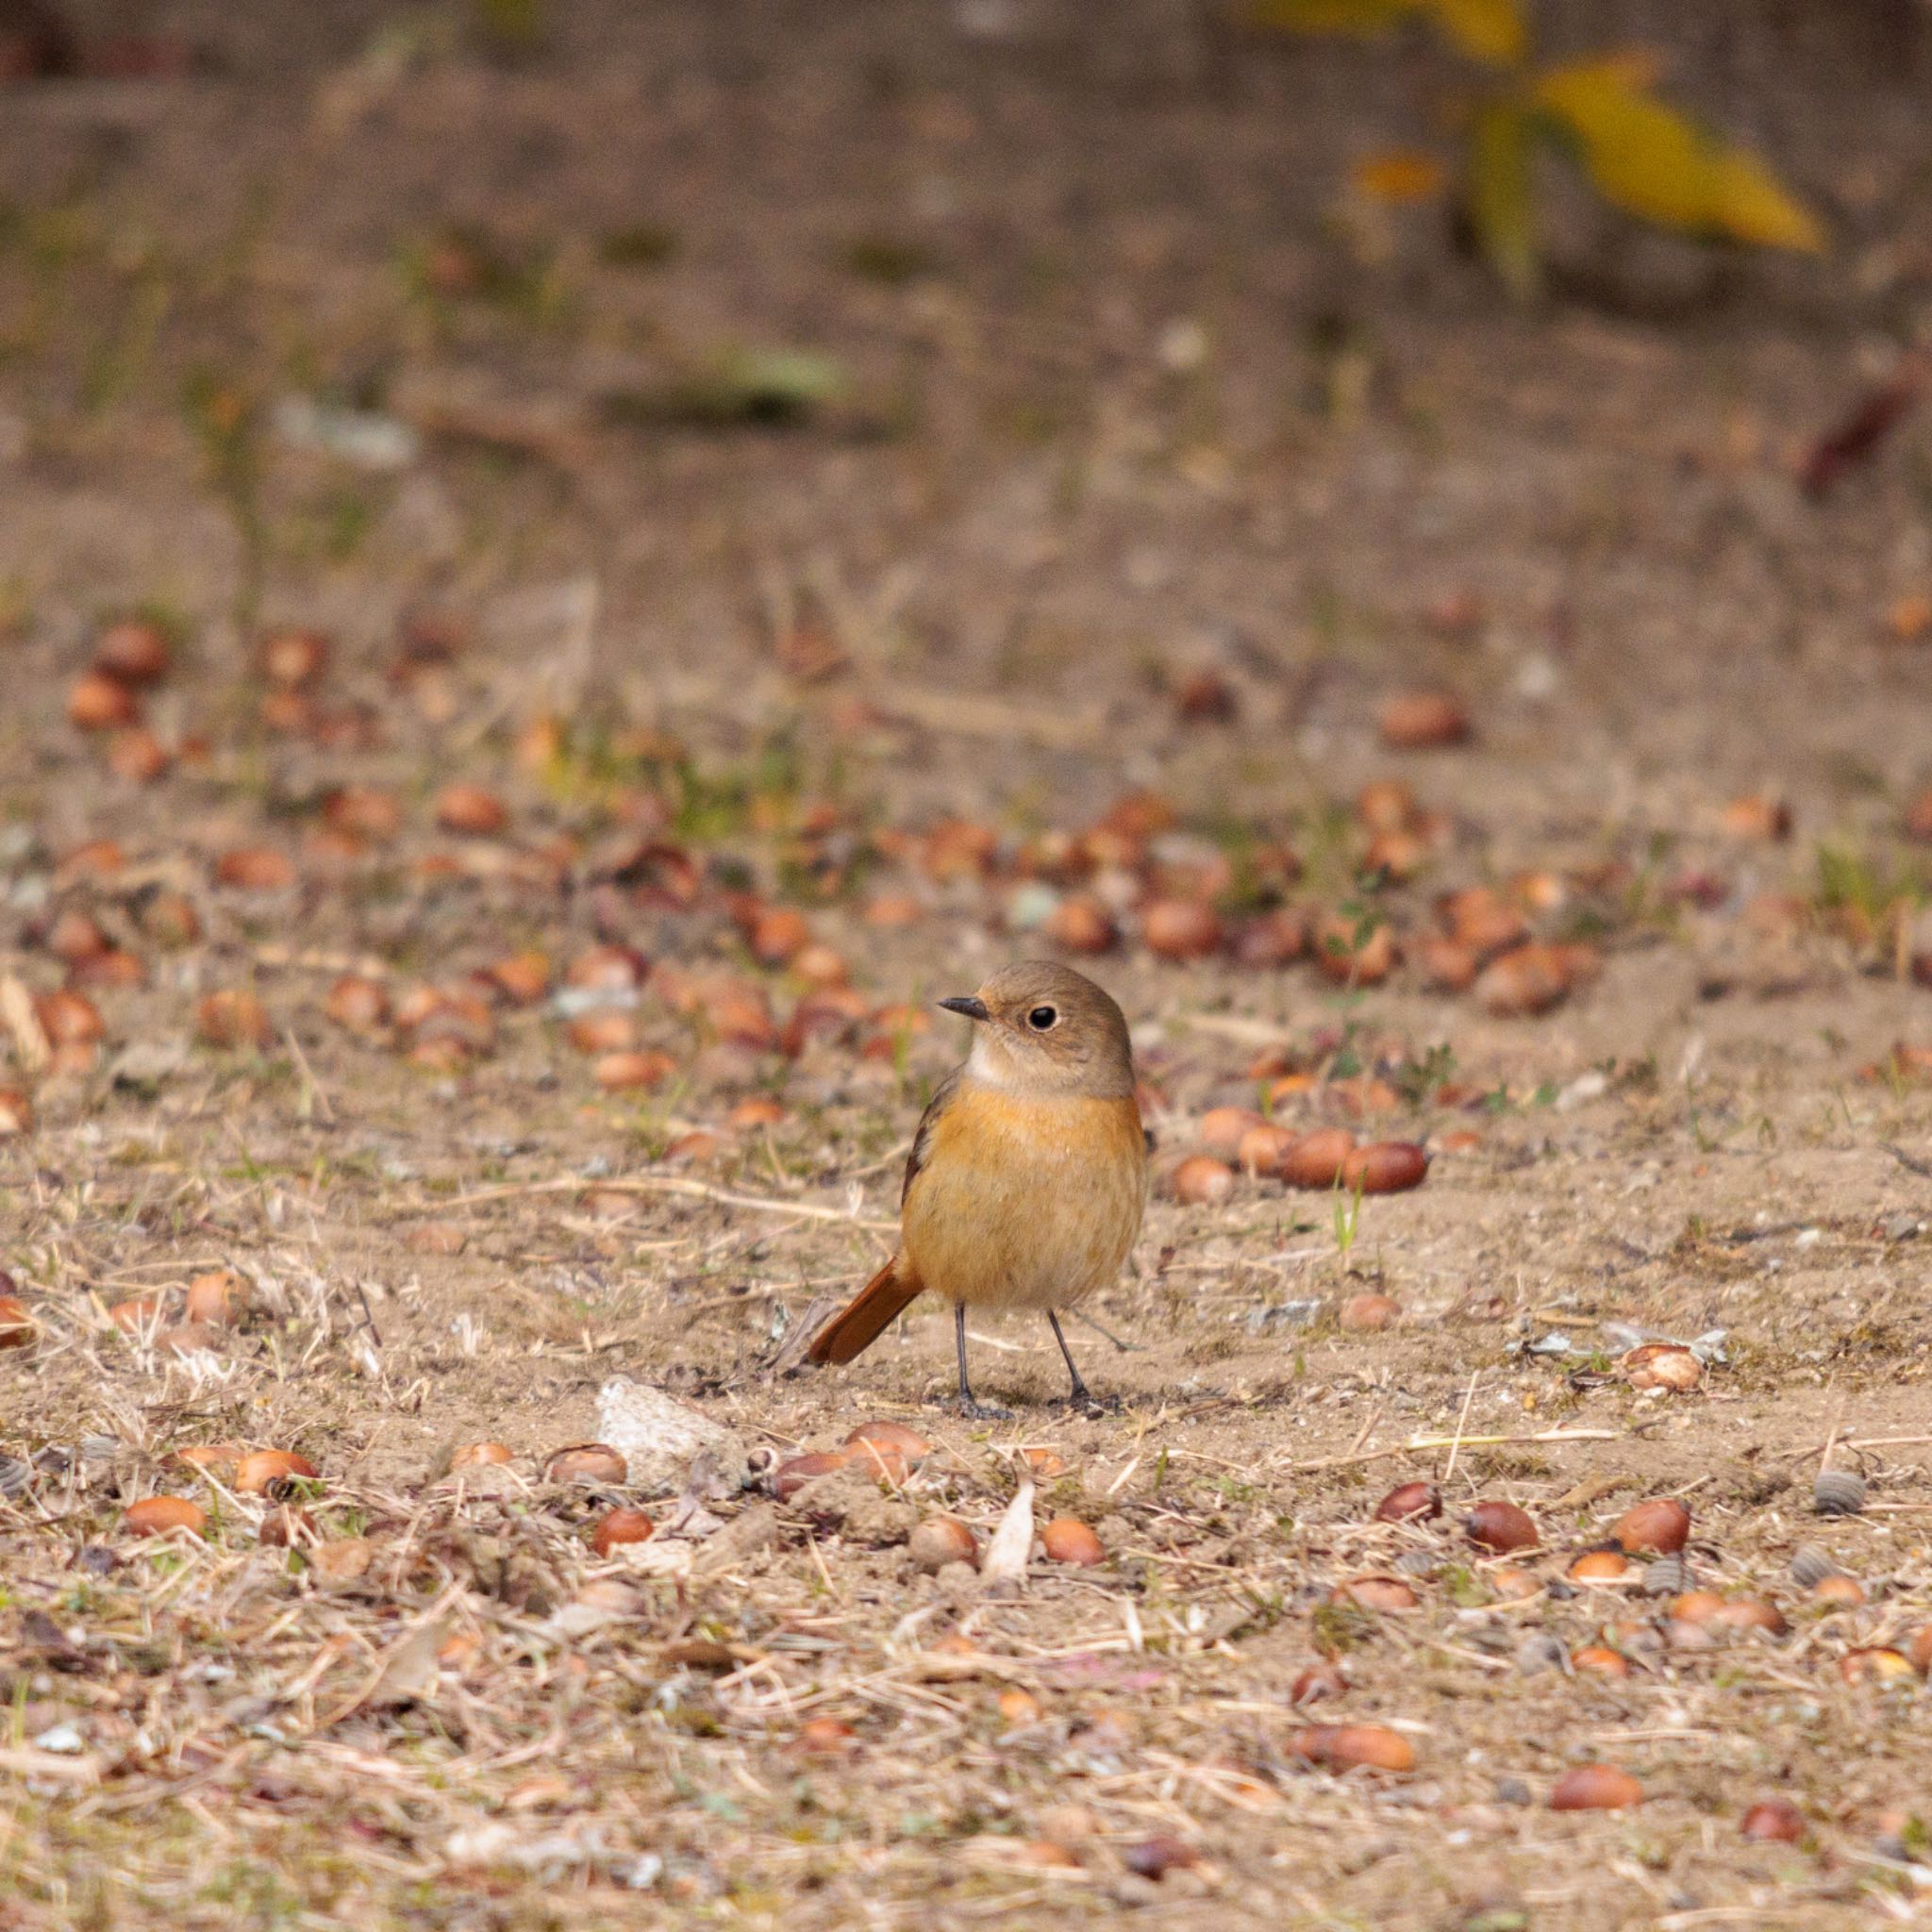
(902, 1088), (1148, 1307)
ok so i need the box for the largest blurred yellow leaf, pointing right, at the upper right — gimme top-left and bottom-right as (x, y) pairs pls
(1534, 56), (1824, 251)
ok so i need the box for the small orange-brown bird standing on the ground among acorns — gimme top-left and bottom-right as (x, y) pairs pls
(808, 960), (1148, 1414)
